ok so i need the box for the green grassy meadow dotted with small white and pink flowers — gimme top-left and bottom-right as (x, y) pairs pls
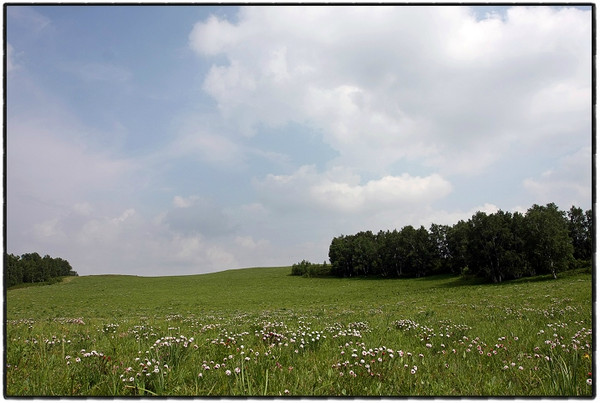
(5, 267), (595, 397)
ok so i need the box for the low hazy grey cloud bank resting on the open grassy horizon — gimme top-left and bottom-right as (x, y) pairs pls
(17, 200), (255, 275)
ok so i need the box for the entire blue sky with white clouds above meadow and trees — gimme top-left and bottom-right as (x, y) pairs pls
(5, 5), (592, 276)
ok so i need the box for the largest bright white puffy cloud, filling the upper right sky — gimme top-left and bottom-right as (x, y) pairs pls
(190, 6), (591, 173)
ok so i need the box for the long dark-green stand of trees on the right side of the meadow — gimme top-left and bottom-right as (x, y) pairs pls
(292, 203), (593, 283)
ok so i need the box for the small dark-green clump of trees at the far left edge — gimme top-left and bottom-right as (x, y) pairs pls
(4, 252), (77, 288)
